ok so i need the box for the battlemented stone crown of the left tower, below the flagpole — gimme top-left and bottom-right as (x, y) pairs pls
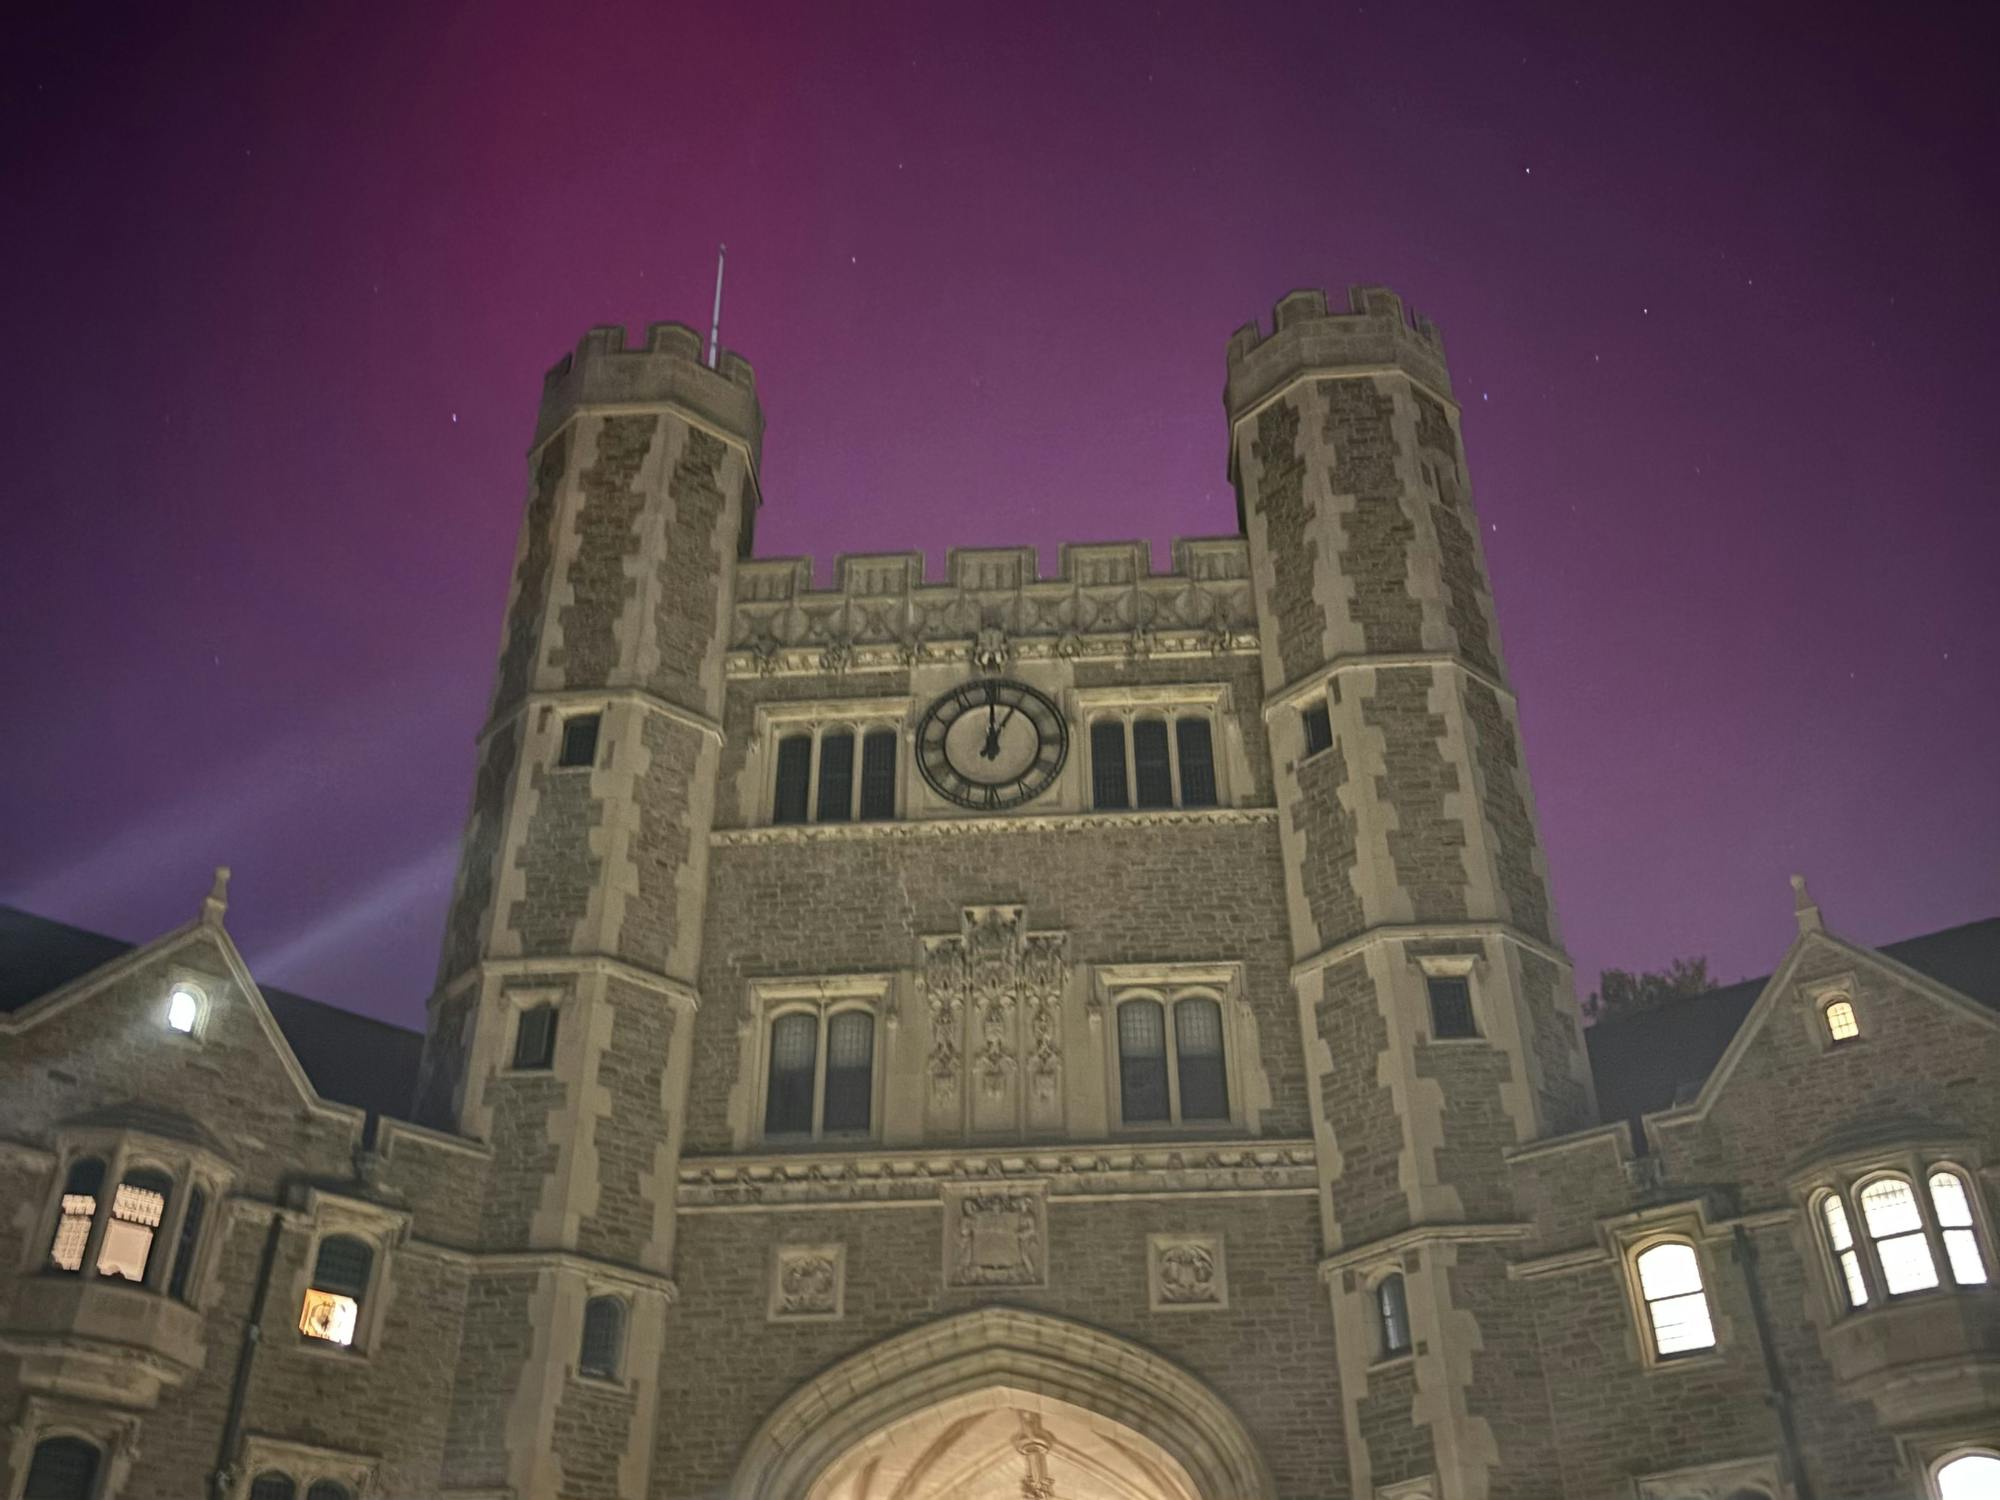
(534, 322), (764, 462)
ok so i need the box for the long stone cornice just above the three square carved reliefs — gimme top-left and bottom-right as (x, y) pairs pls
(678, 1140), (1318, 1212)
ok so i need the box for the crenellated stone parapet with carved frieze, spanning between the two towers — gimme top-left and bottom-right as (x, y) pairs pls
(728, 536), (1256, 676)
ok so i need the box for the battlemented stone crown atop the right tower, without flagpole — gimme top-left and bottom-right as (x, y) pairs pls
(1222, 286), (1452, 422)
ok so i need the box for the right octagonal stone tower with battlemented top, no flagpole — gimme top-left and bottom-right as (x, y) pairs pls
(1224, 288), (1594, 1496)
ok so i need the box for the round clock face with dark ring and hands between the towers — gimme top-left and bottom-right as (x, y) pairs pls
(916, 678), (1070, 812)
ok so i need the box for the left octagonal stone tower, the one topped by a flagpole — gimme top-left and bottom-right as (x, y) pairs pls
(418, 324), (762, 1500)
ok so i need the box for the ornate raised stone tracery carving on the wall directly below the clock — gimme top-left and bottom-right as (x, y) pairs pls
(916, 906), (1070, 1106)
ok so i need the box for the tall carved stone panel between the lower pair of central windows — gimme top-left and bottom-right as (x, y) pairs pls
(916, 906), (1070, 1132)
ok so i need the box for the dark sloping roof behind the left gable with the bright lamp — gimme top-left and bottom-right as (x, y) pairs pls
(0, 906), (424, 1120)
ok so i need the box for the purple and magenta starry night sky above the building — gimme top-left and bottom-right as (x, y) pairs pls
(0, 0), (2000, 1024)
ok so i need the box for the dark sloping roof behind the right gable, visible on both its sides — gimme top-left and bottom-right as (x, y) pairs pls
(1584, 916), (2000, 1132)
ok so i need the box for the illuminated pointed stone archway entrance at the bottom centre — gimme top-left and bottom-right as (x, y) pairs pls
(730, 1308), (1274, 1500)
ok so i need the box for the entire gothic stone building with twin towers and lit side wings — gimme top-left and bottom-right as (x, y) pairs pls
(0, 288), (2000, 1500)
